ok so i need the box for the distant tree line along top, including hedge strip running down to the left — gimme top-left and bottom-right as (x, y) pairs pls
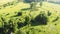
(0, 0), (44, 9)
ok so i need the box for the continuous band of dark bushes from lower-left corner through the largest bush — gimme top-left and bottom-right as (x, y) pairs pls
(0, 12), (47, 34)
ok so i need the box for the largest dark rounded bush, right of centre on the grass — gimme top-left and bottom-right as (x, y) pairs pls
(31, 11), (48, 25)
